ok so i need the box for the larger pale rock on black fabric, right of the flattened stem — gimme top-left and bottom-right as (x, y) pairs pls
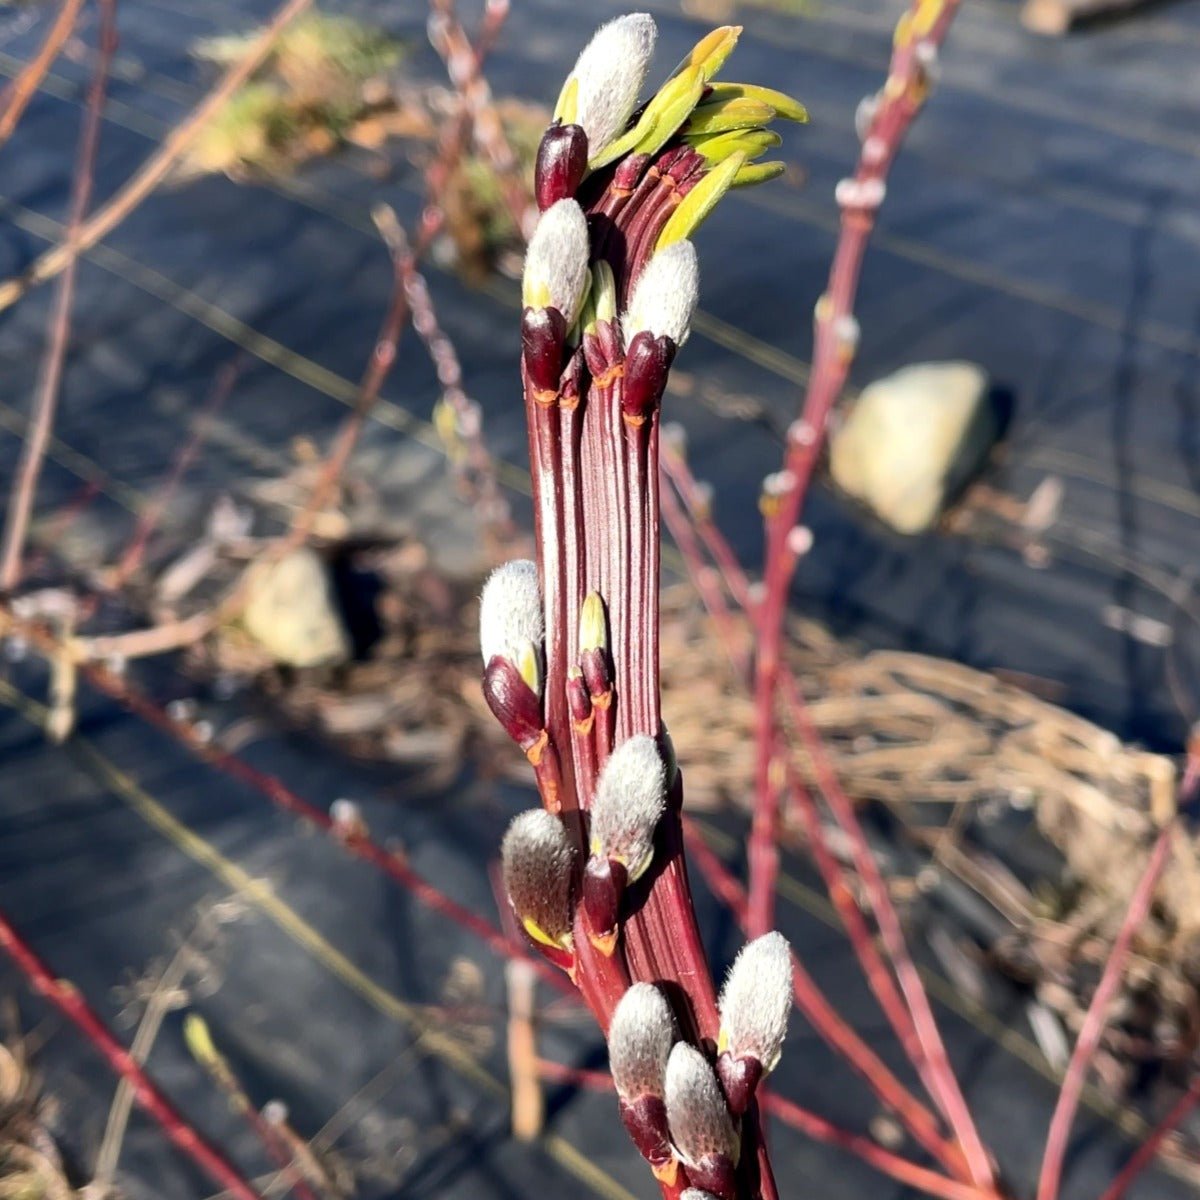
(829, 362), (1000, 534)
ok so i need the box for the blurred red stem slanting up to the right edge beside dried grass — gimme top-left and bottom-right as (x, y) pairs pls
(1037, 750), (1200, 1200)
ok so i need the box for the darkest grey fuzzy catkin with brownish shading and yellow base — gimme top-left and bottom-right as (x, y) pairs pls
(500, 809), (575, 944)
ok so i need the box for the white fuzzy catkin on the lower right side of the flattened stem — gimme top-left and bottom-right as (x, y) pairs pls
(719, 934), (792, 1070)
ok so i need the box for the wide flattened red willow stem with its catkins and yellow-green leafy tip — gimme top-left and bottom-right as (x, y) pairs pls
(481, 14), (804, 1200)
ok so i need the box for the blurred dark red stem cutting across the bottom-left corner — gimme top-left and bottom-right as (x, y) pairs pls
(0, 914), (260, 1200)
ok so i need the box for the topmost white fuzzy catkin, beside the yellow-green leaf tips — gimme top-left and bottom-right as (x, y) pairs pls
(568, 12), (658, 158)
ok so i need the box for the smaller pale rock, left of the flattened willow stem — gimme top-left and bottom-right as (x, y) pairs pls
(241, 547), (352, 667)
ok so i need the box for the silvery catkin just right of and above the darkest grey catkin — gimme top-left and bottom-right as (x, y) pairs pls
(590, 733), (667, 880)
